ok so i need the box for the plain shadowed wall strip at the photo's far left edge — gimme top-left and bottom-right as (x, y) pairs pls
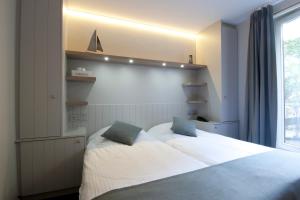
(0, 0), (18, 200)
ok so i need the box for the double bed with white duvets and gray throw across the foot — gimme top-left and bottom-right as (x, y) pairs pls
(80, 123), (300, 200)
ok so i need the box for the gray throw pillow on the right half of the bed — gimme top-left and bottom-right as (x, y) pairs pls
(171, 117), (197, 137)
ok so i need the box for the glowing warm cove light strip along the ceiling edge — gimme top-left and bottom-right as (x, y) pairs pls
(64, 8), (198, 40)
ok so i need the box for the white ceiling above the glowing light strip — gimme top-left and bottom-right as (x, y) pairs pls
(65, 0), (278, 32)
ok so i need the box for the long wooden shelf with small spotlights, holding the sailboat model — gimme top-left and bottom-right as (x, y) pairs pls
(66, 51), (207, 70)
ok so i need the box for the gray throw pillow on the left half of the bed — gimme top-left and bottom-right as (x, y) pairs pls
(102, 121), (142, 146)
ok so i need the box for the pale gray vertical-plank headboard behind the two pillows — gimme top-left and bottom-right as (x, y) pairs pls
(69, 103), (189, 136)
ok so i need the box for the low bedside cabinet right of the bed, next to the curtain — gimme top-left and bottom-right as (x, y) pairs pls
(196, 121), (239, 138)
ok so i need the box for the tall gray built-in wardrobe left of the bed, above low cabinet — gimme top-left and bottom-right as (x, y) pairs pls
(19, 0), (63, 139)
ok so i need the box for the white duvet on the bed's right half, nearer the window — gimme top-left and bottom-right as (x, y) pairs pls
(147, 123), (273, 165)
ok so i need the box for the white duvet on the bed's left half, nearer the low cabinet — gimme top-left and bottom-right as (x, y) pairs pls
(80, 127), (207, 200)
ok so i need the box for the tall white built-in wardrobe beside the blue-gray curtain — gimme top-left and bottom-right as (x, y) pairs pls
(196, 21), (238, 122)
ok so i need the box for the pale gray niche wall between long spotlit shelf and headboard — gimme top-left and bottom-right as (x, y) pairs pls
(67, 60), (207, 128)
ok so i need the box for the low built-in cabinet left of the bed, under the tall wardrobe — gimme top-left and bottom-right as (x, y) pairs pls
(19, 136), (85, 196)
